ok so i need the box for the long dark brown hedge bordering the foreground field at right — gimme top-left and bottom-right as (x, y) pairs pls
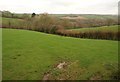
(56, 29), (120, 40)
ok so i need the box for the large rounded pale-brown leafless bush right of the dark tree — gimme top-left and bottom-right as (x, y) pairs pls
(31, 13), (57, 33)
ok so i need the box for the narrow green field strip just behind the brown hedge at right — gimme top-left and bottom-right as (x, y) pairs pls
(70, 25), (119, 32)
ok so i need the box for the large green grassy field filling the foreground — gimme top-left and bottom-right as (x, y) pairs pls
(2, 29), (118, 80)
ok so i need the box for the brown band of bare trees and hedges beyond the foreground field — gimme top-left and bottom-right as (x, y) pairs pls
(2, 13), (120, 40)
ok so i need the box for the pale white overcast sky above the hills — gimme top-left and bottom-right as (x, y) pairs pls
(0, 0), (119, 14)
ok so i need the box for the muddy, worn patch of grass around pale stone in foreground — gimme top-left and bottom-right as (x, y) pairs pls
(43, 61), (84, 80)
